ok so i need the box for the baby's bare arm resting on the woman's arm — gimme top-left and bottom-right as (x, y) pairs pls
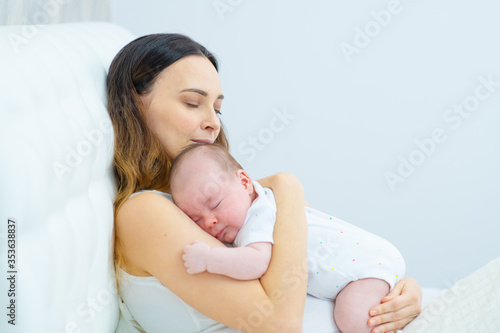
(182, 241), (272, 280)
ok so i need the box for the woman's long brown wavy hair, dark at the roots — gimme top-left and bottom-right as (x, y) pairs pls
(106, 34), (229, 286)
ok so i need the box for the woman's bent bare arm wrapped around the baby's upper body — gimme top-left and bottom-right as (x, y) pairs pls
(116, 174), (307, 332)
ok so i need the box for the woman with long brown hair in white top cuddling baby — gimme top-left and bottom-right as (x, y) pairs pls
(107, 34), (421, 332)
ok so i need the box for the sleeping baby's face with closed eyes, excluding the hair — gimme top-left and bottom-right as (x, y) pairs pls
(172, 161), (253, 243)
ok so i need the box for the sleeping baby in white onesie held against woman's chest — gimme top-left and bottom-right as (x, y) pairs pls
(170, 144), (405, 332)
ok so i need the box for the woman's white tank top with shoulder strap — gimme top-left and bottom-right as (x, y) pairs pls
(116, 191), (238, 333)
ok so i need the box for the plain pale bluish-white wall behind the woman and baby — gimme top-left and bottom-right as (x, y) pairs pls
(111, 0), (500, 287)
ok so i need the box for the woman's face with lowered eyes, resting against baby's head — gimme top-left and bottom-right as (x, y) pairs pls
(143, 55), (224, 158)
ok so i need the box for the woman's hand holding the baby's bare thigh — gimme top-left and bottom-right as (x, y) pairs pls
(368, 278), (422, 333)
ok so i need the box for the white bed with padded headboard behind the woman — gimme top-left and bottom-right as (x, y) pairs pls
(0, 22), (500, 333)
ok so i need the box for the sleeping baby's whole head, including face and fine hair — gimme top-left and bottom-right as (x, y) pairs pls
(170, 144), (257, 243)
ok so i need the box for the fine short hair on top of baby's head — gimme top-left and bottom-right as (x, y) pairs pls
(169, 143), (243, 181)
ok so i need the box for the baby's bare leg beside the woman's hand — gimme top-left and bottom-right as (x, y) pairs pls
(333, 278), (389, 333)
